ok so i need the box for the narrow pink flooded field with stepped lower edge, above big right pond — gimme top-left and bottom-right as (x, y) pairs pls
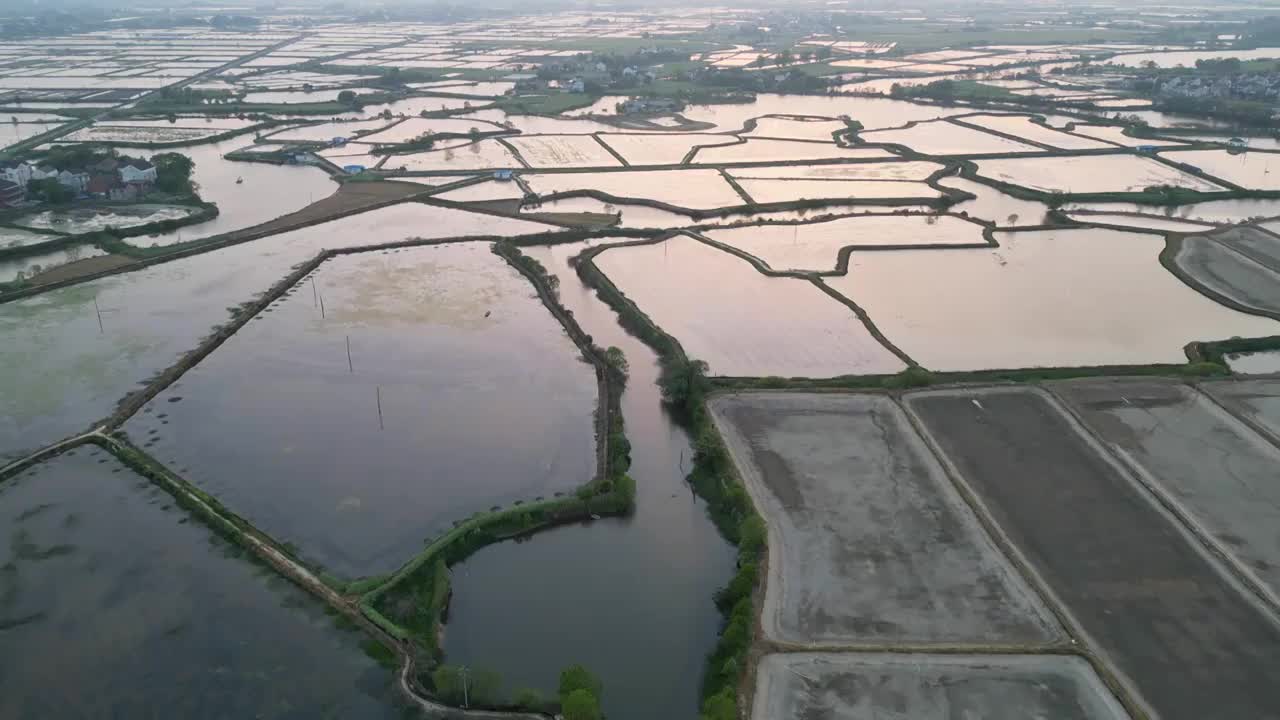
(703, 215), (987, 272)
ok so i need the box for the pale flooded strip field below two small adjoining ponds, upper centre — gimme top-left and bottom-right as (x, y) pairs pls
(524, 169), (746, 210)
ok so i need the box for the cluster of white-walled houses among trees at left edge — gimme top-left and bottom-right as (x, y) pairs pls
(0, 158), (156, 208)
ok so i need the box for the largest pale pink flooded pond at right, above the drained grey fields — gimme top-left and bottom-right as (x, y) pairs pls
(823, 229), (1280, 370)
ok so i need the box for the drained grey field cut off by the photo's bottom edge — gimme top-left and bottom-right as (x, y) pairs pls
(751, 652), (1129, 720)
